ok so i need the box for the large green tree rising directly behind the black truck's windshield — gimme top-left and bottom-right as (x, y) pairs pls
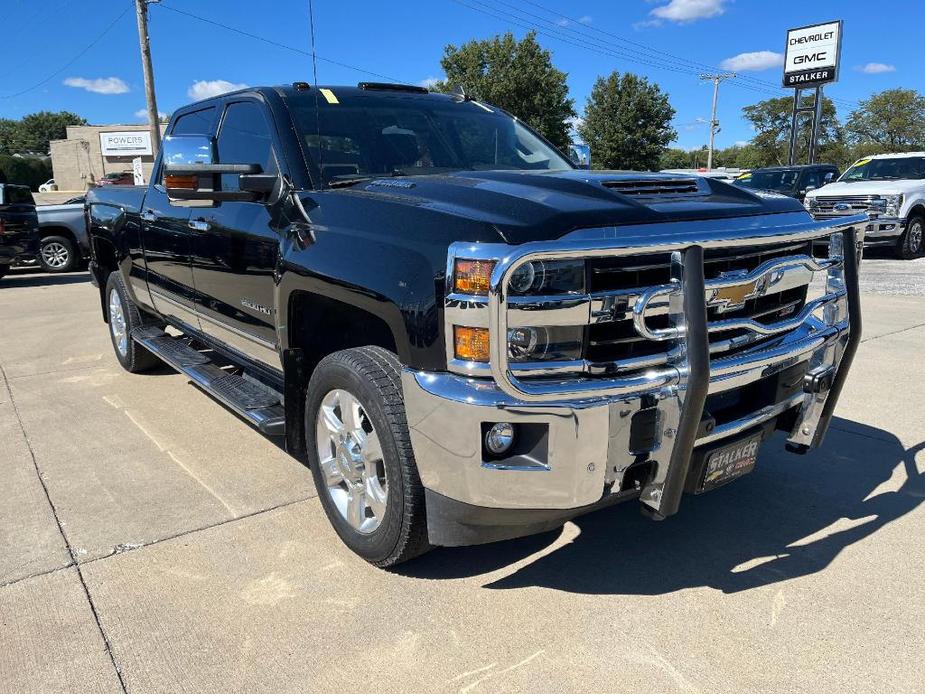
(433, 31), (575, 151)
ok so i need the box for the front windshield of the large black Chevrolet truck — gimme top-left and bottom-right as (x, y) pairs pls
(291, 90), (573, 184)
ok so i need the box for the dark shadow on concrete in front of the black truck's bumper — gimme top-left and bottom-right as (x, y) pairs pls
(402, 419), (925, 595)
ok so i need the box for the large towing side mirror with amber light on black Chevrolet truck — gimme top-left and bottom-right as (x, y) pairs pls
(162, 135), (268, 202)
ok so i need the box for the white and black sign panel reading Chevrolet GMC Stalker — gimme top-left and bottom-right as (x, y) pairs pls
(784, 20), (842, 88)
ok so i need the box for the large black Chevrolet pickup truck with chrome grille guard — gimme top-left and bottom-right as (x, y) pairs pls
(88, 83), (866, 566)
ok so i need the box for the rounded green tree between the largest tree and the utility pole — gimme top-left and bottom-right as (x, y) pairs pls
(578, 71), (678, 171)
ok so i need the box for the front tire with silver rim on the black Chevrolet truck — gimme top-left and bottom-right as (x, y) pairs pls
(305, 347), (430, 567)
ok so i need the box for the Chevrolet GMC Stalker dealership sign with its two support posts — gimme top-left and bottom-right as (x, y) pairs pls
(784, 20), (842, 166)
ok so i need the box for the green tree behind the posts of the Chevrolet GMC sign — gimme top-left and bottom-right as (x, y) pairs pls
(742, 95), (843, 166)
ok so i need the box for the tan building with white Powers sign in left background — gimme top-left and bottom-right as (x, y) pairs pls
(51, 124), (166, 191)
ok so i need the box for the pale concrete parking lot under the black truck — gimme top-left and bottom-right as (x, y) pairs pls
(0, 256), (925, 694)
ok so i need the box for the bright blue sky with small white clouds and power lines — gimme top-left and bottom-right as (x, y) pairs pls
(0, 0), (925, 148)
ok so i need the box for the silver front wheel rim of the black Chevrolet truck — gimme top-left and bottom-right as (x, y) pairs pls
(315, 389), (389, 534)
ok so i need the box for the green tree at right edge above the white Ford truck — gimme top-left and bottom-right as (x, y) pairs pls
(845, 89), (925, 152)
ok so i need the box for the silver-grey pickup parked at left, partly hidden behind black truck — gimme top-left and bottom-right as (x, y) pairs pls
(35, 197), (90, 272)
